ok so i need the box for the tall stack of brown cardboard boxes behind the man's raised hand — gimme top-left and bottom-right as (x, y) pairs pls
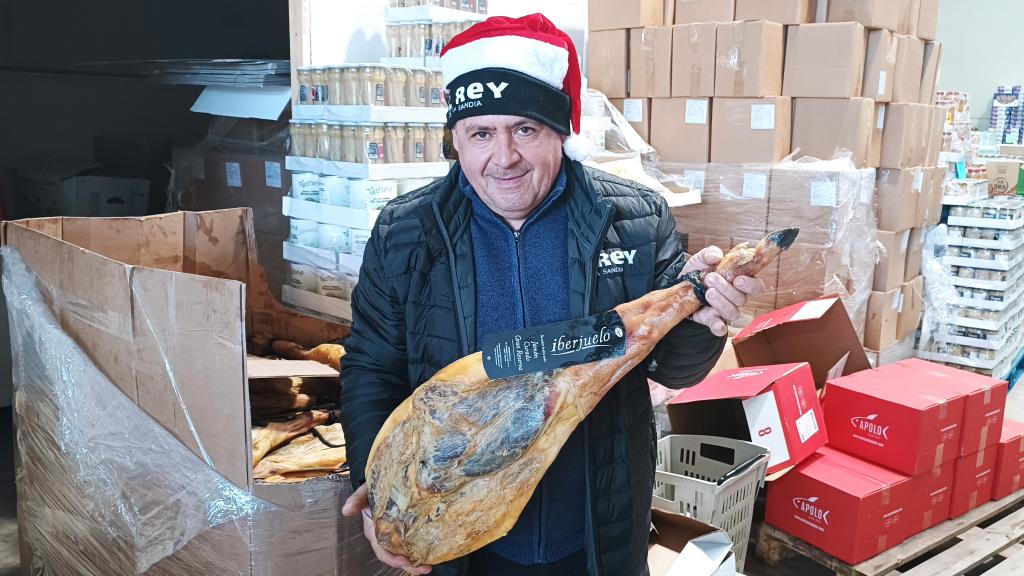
(588, 0), (945, 352)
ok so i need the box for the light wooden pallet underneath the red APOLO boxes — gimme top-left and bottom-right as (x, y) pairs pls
(758, 491), (1024, 576)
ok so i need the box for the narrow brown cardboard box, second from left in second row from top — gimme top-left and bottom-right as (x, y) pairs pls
(629, 27), (672, 98)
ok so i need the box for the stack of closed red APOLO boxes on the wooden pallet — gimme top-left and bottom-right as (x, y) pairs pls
(765, 360), (1011, 564)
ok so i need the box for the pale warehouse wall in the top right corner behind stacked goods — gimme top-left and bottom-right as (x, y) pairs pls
(938, 0), (1024, 128)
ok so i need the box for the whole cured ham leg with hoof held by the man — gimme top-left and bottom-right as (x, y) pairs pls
(367, 229), (799, 565)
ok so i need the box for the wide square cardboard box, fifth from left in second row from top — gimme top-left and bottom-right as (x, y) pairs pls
(782, 23), (865, 98)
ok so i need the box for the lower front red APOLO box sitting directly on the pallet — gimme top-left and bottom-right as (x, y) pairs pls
(765, 448), (911, 564)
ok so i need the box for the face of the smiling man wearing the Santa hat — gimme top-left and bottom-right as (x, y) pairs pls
(452, 116), (564, 228)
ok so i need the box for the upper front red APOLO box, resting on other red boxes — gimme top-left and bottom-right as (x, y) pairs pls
(822, 370), (965, 476)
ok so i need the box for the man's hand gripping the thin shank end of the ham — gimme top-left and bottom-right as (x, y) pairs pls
(680, 246), (765, 336)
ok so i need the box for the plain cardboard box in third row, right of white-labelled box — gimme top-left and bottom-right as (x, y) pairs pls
(790, 96), (881, 168)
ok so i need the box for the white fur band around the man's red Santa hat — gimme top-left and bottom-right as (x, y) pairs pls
(441, 36), (569, 90)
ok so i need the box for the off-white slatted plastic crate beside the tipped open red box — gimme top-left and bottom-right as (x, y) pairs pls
(653, 435), (768, 571)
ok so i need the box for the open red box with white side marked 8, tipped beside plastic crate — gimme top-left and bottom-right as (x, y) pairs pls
(667, 363), (827, 474)
